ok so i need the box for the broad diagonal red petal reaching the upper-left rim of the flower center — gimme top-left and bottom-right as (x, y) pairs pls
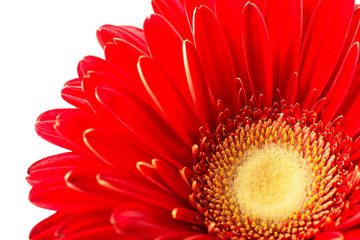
(97, 87), (192, 168)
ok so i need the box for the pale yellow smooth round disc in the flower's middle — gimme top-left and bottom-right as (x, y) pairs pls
(229, 144), (311, 223)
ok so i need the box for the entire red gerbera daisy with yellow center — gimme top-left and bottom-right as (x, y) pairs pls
(28, 0), (360, 240)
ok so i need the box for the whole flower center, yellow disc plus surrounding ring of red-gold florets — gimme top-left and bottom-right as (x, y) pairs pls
(190, 105), (351, 240)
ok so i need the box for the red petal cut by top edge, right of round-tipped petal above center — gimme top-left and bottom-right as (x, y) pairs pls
(264, 0), (302, 95)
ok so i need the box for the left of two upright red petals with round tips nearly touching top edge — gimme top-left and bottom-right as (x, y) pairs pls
(194, 6), (238, 113)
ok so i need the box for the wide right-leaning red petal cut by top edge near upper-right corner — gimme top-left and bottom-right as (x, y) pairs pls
(297, 0), (354, 108)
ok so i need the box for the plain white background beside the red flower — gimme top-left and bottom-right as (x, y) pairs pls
(0, 0), (360, 240)
